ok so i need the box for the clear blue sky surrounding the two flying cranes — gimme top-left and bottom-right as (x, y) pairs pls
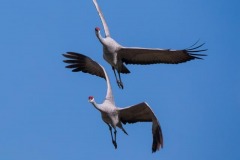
(0, 0), (240, 160)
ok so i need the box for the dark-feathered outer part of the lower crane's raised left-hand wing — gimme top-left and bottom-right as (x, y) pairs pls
(63, 52), (106, 79)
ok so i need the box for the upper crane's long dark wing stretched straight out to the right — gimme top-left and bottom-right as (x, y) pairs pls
(118, 43), (207, 65)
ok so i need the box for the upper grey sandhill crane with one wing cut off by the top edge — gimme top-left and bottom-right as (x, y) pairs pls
(93, 0), (206, 89)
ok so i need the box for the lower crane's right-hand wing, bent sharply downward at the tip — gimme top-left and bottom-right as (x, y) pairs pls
(119, 102), (163, 152)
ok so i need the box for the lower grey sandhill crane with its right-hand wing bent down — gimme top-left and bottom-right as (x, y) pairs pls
(63, 52), (163, 152)
